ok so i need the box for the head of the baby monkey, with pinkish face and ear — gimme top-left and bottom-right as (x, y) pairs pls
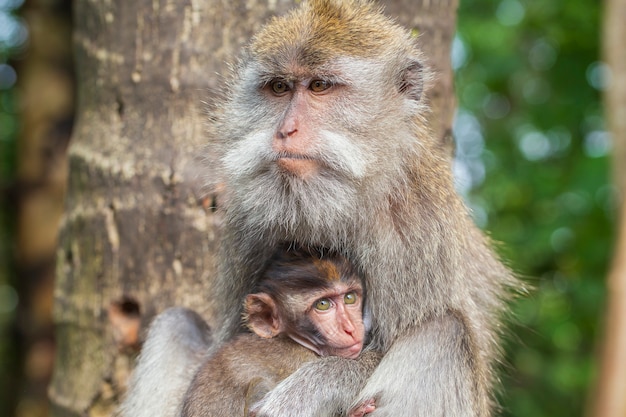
(244, 246), (365, 358)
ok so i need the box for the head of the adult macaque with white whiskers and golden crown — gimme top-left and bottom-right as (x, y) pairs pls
(212, 1), (424, 244)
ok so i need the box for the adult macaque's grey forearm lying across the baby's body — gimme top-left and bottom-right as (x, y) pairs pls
(250, 351), (382, 417)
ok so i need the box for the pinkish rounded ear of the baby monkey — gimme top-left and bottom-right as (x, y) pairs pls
(244, 293), (282, 339)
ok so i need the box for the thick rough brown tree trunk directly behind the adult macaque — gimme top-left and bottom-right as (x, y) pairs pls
(50, 0), (457, 416)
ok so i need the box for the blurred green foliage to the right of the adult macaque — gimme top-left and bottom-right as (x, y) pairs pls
(453, 0), (614, 417)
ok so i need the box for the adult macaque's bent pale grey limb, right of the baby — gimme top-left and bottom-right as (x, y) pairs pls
(353, 314), (488, 417)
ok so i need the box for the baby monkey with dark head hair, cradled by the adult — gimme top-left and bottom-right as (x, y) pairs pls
(182, 248), (375, 417)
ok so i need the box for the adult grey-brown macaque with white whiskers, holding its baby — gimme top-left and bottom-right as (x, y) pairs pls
(119, 0), (517, 417)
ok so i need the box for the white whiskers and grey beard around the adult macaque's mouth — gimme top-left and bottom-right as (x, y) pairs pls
(221, 129), (371, 246)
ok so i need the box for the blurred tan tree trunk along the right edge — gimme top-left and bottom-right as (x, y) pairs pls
(590, 0), (626, 417)
